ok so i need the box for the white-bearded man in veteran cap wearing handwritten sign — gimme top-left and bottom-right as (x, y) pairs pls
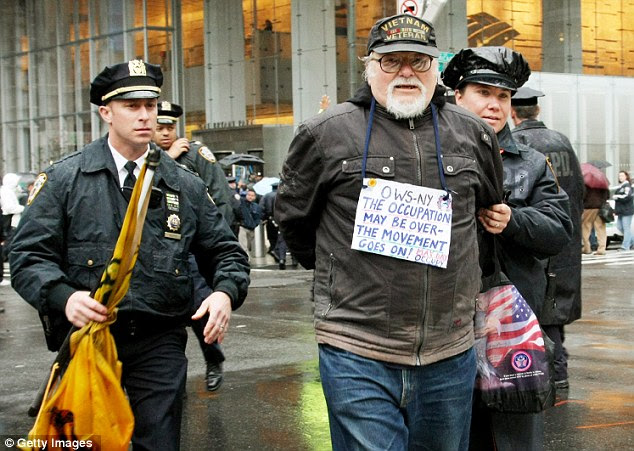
(275, 15), (509, 450)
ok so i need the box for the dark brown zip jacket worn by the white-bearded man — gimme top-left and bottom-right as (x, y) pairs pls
(275, 84), (502, 365)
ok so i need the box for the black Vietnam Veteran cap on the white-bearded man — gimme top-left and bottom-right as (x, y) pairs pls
(367, 14), (440, 58)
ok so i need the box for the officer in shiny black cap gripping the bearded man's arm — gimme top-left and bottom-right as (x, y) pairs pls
(442, 47), (573, 451)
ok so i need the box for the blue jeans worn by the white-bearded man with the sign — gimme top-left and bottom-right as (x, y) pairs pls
(319, 345), (476, 451)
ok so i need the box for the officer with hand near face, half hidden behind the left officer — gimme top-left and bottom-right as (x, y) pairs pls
(153, 101), (234, 391)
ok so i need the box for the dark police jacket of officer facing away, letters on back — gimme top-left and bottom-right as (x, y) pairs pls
(512, 119), (584, 325)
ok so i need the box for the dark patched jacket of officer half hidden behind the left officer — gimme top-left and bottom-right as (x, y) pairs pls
(176, 141), (235, 224)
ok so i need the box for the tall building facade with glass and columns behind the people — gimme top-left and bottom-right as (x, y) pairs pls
(0, 0), (634, 178)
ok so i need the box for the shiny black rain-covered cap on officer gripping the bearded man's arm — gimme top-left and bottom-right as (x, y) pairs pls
(442, 47), (531, 92)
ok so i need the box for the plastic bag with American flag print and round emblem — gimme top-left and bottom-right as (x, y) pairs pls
(475, 273), (555, 413)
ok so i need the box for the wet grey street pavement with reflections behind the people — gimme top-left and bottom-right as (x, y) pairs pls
(0, 250), (634, 450)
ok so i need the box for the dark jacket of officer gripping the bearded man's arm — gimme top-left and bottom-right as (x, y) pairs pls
(498, 125), (573, 321)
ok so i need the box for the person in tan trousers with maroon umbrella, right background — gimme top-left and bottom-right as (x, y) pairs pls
(581, 163), (610, 255)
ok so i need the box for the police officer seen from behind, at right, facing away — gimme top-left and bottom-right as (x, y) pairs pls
(511, 86), (584, 389)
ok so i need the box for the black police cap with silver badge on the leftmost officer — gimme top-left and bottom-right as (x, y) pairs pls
(90, 60), (163, 106)
